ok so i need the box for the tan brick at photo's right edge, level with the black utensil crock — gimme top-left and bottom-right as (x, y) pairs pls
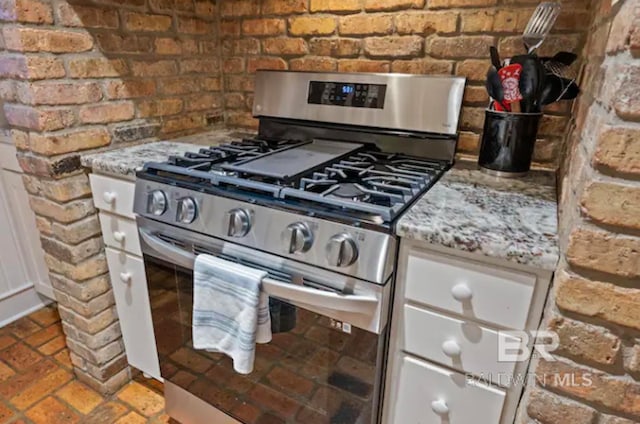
(594, 126), (640, 175)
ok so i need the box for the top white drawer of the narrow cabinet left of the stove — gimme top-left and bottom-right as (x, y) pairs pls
(89, 174), (135, 218)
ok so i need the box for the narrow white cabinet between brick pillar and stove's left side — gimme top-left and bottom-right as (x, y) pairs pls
(89, 174), (161, 380)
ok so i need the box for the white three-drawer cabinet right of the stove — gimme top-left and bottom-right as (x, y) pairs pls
(383, 239), (551, 424)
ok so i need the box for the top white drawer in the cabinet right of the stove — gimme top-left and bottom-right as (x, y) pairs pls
(405, 249), (536, 330)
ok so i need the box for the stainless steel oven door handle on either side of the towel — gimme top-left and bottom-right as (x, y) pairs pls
(139, 228), (380, 314)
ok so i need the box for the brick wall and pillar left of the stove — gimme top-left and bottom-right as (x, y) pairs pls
(0, 0), (222, 393)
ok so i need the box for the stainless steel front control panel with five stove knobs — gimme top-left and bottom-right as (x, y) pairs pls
(134, 179), (397, 284)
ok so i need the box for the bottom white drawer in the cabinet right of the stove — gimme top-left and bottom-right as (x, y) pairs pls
(389, 355), (505, 424)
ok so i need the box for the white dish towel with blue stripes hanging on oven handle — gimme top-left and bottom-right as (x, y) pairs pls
(193, 255), (271, 374)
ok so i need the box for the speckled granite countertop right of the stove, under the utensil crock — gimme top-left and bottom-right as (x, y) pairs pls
(396, 162), (559, 271)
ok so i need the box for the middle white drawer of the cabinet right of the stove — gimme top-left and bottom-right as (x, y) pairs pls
(400, 305), (520, 386)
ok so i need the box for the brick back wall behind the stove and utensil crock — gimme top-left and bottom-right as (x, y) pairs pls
(219, 0), (591, 167)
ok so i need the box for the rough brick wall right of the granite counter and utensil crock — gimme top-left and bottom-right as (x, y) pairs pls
(519, 0), (640, 424)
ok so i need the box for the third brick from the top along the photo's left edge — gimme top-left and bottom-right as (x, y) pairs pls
(0, 54), (65, 80)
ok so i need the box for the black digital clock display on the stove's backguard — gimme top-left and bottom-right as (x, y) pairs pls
(307, 81), (387, 109)
